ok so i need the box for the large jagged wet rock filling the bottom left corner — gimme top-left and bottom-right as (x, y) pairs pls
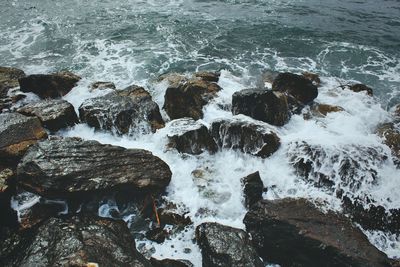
(0, 217), (151, 267)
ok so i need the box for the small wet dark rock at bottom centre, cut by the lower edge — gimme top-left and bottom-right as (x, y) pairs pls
(196, 223), (264, 267)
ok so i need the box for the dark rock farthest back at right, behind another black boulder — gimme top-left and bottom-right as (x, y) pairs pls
(272, 72), (318, 113)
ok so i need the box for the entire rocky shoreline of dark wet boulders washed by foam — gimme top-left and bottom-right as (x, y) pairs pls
(0, 67), (400, 266)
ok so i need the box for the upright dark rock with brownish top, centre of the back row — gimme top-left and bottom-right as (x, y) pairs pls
(163, 78), (221, 120)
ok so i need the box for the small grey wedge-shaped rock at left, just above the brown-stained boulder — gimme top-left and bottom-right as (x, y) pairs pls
(17, 99), (79, 132)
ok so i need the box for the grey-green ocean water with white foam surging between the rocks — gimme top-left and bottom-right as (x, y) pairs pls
(0, 0), (400, 266)
